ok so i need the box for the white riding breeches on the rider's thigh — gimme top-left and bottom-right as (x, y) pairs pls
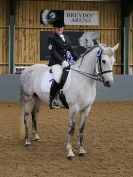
(51, 64), (63, 84)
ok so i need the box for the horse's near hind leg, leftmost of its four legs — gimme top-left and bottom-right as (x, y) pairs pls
(24, 96), (32, 147)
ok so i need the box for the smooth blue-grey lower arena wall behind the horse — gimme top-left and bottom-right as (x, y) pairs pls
(0, 74), (133, 102)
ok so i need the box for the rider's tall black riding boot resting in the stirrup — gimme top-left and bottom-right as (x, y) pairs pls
(49, 80), (60, 109)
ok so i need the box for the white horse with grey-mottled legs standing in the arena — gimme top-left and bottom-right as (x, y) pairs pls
(20, 43), (119, 160)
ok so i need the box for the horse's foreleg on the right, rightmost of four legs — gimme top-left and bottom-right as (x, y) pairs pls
(79, 106), (91, 156)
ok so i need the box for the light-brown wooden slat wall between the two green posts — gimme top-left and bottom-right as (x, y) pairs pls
(15, 0), (121, 74)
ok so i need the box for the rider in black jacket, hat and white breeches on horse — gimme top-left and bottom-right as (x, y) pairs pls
(48, 20), (78, 109)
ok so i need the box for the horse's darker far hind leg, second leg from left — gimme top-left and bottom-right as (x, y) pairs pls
(31, 95), (41, 141)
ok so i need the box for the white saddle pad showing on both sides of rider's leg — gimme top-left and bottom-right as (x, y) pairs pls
(41, 70), (71, 93)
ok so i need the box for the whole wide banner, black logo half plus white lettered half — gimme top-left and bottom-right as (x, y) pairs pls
(40, 10), (99, 26)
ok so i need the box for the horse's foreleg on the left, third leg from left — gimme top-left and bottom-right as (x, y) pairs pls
(67, 108), (77, 160)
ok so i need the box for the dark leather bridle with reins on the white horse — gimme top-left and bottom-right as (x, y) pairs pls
(71, 46), (113, 82)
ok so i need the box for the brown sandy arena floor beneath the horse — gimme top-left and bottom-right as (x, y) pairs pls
(0, 101), (133, 177)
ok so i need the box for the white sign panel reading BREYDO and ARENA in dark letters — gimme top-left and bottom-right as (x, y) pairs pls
(64, 10), (99, 25)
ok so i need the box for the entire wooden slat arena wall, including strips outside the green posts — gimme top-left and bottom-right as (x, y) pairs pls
(0, 0), (133, 74)
